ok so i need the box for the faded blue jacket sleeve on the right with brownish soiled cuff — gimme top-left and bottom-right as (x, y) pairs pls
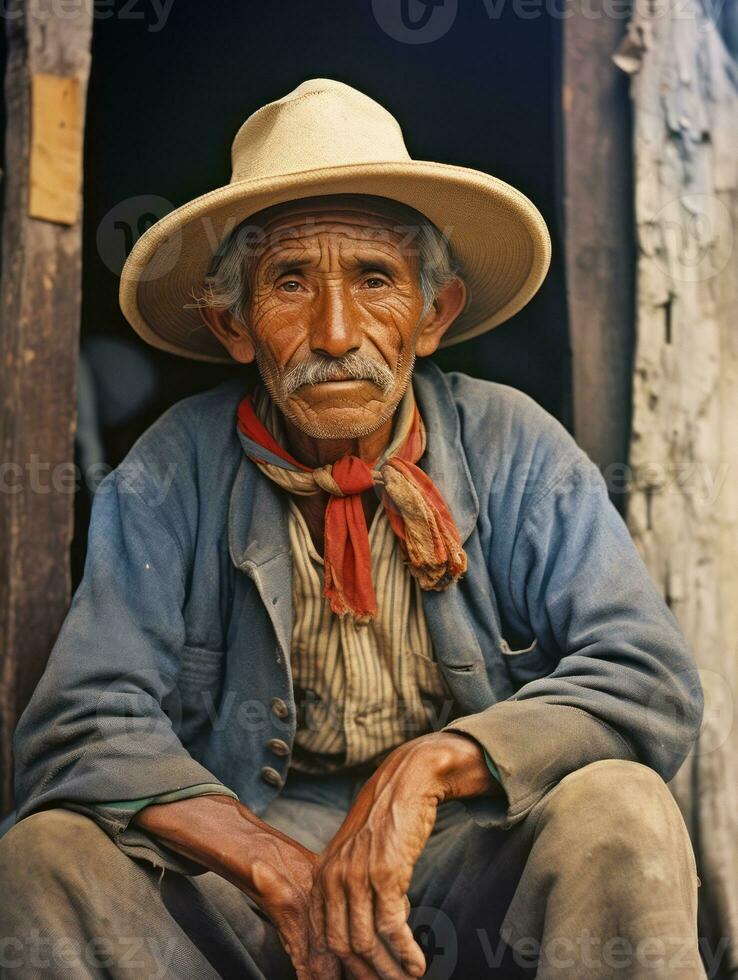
(448, 454), (702, 826)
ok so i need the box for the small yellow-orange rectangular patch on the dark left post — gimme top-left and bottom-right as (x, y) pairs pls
(28, 74), (83, 225)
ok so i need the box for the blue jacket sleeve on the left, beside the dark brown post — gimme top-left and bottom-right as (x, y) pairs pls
(14, 470), (233, 870)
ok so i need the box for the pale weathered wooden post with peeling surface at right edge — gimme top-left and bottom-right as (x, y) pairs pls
(618, 0), (738, 977)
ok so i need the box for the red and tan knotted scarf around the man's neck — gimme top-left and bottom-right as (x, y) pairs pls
(238, 388), (466, 622)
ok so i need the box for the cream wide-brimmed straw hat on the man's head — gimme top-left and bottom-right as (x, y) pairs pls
(120, 78), (550, 363)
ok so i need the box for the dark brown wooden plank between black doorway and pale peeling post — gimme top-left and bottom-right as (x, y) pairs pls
(559, 0), (635, 486)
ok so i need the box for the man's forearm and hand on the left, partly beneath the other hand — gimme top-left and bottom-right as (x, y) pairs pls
(134, 796), (341, 980)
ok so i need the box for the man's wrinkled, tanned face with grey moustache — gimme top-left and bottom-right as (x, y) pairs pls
(208, 201), (463, 439)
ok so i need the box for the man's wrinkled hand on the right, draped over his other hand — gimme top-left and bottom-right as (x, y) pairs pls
(310, 732), (495, 980)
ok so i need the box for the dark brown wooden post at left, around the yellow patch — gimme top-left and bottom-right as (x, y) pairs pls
(0, 0), (92, 809)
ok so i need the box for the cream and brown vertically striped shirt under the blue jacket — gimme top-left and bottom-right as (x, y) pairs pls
(288, 503), (450, 772)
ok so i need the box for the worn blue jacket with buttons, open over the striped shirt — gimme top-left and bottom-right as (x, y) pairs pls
(15, 364), (702, 856)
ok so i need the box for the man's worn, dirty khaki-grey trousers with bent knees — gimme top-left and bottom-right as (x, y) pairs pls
(0, 761), (705, 980)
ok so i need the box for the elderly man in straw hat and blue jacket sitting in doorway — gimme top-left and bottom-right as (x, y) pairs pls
(0, 79), (704, 980)
